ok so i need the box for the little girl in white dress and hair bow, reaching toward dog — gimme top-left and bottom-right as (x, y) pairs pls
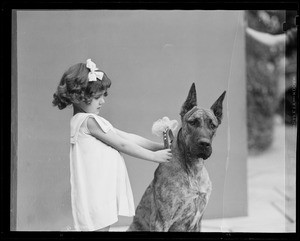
(52, 59), (172, 231)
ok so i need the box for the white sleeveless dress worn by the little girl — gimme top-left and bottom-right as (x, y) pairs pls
(70, 113), (135, 231)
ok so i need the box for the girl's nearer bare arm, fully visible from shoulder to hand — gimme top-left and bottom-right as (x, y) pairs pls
(87, 118), (172, 163)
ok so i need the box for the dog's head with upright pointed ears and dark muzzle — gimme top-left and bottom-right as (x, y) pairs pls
(180, 83), (226, 160)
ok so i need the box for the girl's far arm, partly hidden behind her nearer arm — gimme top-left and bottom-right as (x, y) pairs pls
(115, 128), (165, 151)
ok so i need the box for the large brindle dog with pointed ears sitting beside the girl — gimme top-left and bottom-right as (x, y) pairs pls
(128, 83), (226, 232)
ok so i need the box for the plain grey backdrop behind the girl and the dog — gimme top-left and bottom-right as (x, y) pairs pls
(14, 10), (247, 230)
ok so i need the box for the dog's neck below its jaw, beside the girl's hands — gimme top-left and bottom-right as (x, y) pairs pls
(172, 128), (204, 176)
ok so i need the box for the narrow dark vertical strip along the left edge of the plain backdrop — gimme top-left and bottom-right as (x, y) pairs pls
(10, 10), (18, 231)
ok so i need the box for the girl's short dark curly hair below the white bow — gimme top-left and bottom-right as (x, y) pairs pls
(52, 63), (111, 110)
